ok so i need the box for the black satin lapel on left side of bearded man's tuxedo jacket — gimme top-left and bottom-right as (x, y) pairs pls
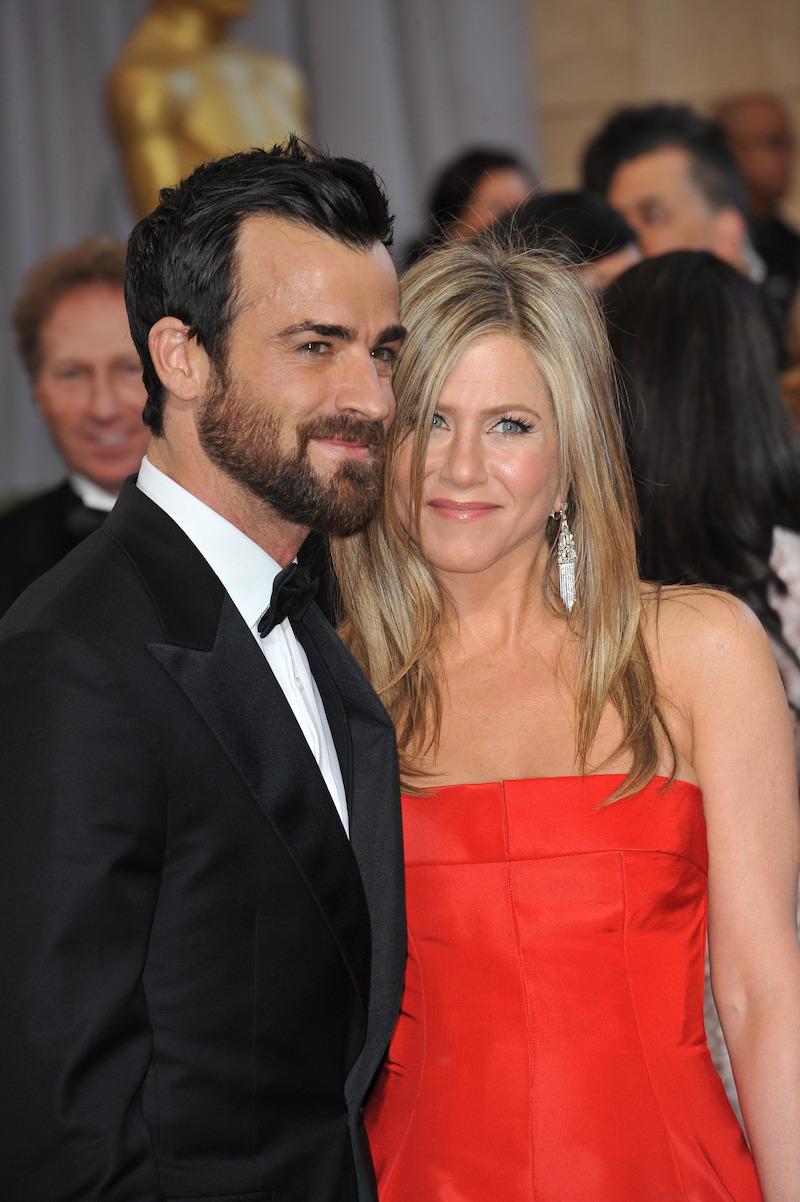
(105, 488), (370, 1010)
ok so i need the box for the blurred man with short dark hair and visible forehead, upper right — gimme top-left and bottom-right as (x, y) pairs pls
(583, 103), (764, 282)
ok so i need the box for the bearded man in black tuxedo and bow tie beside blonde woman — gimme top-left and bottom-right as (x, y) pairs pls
(0, 139), (405, 1202)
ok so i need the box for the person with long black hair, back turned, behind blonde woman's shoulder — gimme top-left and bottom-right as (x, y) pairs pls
(605, 251), (800, 1118)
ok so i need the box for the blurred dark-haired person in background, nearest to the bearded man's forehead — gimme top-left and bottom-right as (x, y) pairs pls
(406, 147), (536, 264)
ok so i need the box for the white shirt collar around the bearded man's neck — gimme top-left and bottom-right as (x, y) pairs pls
(137, 456), (281, 629)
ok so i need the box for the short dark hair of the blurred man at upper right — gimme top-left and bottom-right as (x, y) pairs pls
(583, 105), (747, 215)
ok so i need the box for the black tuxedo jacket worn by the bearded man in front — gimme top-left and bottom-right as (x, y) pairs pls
(0, 481), (405, 1202)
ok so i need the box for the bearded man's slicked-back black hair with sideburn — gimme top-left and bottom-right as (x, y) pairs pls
(125, 137), (392, 434)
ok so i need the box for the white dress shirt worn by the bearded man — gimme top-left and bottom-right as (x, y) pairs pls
(137, 456), (350, 835)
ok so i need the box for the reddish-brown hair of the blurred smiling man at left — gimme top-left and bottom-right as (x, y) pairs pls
(11, 236), (125, 380)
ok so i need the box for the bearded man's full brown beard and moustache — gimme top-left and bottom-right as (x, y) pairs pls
(197, 369), (386, 535)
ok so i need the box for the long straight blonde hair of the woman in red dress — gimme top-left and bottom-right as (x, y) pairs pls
(333, 238), (674, 797)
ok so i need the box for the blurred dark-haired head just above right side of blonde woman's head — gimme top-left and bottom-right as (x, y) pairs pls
(494, 192), (641, 291)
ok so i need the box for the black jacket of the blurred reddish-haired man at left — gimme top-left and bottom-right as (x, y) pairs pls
(0, 481), (106, 614)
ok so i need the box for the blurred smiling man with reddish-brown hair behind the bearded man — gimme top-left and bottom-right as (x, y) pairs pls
(0, 238), (150, 614)
